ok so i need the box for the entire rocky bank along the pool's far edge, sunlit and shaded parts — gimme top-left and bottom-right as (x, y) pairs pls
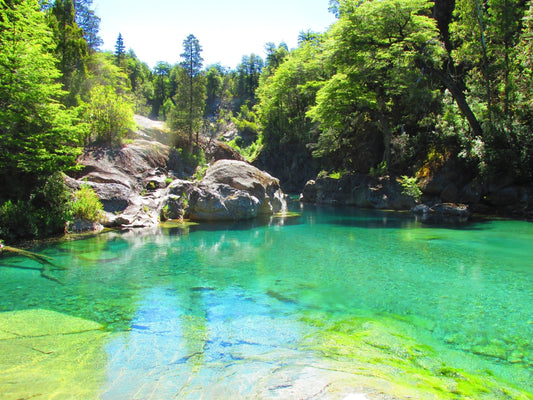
(67, 116), (533, 231)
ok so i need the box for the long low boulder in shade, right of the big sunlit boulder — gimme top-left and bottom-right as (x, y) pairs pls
(300, 173), (415, 210)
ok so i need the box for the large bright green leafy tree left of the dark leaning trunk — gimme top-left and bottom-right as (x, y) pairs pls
(308, 0), (445, 170)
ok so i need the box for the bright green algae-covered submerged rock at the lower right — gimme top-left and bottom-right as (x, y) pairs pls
(302, 313), (531, 400)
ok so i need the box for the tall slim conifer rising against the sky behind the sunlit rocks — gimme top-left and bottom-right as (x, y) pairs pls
(170, 35), (205, 151)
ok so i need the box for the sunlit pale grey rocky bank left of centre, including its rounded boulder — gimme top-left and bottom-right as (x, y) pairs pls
(67, 134), (285, 231)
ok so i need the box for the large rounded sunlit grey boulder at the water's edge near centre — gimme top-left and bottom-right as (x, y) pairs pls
(187, 160), (286, 221)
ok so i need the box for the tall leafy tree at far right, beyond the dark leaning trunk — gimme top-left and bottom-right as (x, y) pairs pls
(450, 0), (531, 179)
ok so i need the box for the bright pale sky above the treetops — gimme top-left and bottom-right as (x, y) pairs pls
(93, 0), (335, 68)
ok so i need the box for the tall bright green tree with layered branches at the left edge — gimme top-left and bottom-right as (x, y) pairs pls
(0, 0), (83, 200)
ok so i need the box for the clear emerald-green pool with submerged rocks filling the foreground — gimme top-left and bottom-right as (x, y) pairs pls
(0, 205), (533, 399)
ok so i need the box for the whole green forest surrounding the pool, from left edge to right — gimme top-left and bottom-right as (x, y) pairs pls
(0, 0), (533, 239)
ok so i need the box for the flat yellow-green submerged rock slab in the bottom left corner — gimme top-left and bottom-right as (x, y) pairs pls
(0, 309), (109, 400)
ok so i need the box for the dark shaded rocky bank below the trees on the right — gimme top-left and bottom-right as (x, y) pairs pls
(300, 173), (533, 220)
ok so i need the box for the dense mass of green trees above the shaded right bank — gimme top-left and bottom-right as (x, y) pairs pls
(252, 0), (533, 182)
